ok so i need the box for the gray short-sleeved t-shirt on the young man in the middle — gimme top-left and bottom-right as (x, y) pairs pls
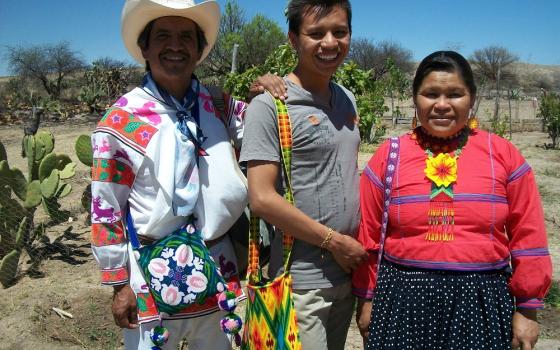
(241, 78), (360, 289)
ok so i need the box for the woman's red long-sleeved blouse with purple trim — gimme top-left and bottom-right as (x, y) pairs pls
(353, 130), (552, 308)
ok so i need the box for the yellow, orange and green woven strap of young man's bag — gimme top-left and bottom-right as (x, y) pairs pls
(247, 95), (294, 283)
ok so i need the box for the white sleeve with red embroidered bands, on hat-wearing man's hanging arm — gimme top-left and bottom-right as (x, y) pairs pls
(91, 109), (153, 285)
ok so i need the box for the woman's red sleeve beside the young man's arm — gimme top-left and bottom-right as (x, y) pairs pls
(352, 143), (388, 300)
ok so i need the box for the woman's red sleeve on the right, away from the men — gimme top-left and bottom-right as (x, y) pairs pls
(506, 141), (552, 309)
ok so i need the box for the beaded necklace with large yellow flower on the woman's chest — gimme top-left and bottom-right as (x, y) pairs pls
(411, 127), (471, 242)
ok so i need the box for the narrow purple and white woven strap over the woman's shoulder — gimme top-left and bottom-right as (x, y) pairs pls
(377, 137), (400, 284)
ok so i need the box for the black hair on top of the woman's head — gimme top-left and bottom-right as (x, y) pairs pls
(412, 51), (476, 96)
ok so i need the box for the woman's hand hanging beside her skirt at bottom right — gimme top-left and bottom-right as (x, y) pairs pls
(511, 309), (539, 350)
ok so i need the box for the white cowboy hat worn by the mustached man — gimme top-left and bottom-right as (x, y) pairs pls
(121, 0), (220, 65)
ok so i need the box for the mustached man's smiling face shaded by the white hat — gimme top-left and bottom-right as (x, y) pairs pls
(142, 17), (200, 98)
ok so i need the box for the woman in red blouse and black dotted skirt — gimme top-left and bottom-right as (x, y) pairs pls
(353, 51), (552, 350)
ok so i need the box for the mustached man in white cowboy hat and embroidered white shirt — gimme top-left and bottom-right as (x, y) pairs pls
(92, 0), (284, 349)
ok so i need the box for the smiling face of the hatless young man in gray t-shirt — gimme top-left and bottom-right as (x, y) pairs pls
(289, 6), (350, 80)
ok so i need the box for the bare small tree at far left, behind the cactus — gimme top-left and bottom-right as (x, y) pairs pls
(7, 42), (84, 99)
